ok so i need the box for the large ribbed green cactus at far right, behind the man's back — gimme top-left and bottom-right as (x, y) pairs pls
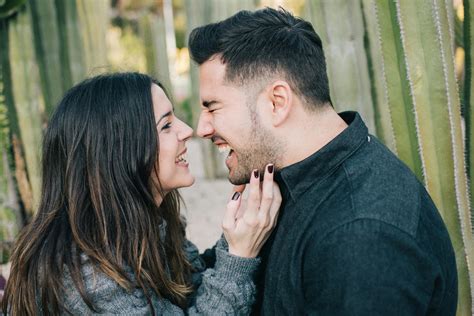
(363, 0), (474, 315)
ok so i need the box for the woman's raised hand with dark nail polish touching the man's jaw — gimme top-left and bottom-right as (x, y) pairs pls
(222, 165), (281, 258)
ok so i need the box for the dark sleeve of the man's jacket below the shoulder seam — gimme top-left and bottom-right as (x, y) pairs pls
(302, 219), (456, 316)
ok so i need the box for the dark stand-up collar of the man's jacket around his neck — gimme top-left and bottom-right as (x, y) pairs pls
(275, 112), (370, 200)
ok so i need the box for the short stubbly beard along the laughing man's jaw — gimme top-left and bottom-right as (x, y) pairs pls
(229, 117), (283, 185)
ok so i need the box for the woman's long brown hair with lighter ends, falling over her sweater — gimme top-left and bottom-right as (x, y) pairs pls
(2, 73), (190, 315)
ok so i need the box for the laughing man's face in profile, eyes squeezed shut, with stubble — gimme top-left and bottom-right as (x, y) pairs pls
(197, 57), (280, 184)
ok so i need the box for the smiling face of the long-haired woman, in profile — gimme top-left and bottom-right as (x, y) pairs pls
(151, 84), (194, 193)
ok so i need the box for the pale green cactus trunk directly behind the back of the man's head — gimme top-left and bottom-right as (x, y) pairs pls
(306, 0), (375, 133)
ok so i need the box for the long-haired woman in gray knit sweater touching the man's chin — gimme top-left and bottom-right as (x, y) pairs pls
(3, 73), (281, 315)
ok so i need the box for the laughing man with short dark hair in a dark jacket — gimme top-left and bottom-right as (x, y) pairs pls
(189, 8), (457, 315)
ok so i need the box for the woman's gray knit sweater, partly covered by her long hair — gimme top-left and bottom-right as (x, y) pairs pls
(60, 239), (260, 315)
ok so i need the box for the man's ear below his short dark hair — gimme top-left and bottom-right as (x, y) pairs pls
(268, 80), (293, 126)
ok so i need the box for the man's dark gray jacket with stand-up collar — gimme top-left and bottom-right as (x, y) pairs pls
(255, 112), (457, 316)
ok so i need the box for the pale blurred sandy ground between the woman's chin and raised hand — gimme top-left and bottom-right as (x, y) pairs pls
(179, 139), (232, 251)
